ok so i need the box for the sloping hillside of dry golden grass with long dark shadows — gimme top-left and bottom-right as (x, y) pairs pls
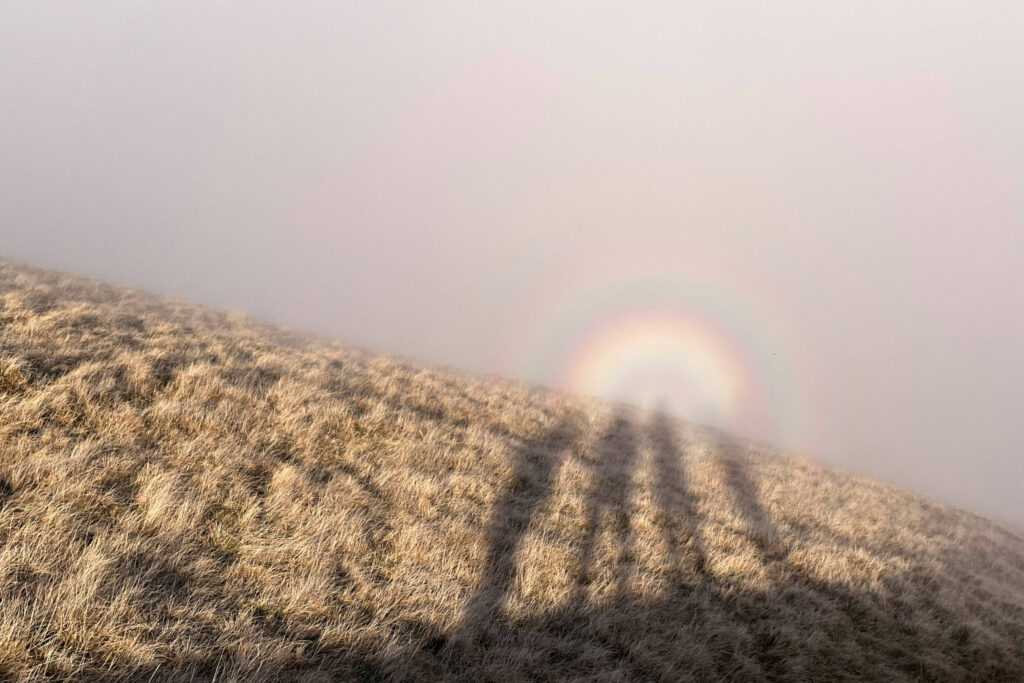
(0, 261), (1024, 681)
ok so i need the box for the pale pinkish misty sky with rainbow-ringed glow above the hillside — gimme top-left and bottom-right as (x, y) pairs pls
(0, 0), (1024, 521)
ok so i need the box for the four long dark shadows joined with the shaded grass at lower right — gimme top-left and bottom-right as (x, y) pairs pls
(413, 411), (1024, 681)
